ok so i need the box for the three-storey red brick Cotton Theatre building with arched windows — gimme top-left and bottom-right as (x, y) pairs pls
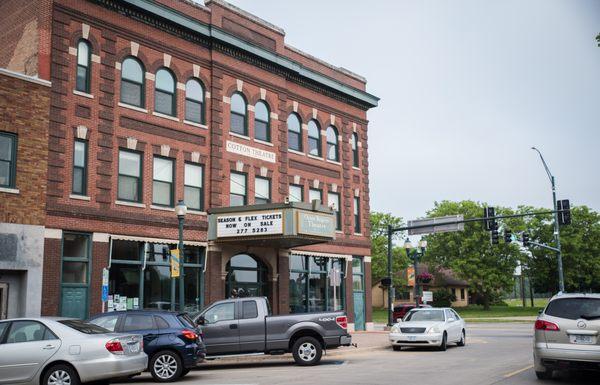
(0, 0), (378, 329)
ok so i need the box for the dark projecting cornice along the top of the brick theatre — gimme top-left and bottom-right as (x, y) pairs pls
(89, 0), (379, 110)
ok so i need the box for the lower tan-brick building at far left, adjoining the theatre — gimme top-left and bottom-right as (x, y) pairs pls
(0, 69), (50, 319)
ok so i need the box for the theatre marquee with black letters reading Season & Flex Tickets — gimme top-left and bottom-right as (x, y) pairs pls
(208, 202), (335, 243)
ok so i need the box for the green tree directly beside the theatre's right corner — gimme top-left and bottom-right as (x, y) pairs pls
(371, 212), (408, 285)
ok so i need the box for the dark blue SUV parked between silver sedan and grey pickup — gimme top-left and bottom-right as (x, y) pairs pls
(89, 310), (206, 382)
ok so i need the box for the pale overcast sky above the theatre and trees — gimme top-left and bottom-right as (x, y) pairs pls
(221, 0), (600, 220)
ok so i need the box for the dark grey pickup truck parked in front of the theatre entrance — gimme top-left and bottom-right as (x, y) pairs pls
(194, 297), (352, 366)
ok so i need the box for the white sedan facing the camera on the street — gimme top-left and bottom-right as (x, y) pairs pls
(390, 308), (466, 350)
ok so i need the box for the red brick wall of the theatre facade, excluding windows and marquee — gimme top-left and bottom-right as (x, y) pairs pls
(1, 0), (371, 330)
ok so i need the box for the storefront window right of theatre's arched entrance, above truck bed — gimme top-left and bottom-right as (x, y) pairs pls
(289, 255), (345, 313)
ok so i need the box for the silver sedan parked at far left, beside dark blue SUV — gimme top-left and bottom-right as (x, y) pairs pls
(0, 317), (148, 385)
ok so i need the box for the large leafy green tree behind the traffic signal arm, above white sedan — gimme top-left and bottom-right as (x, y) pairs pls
(424, 200), (523, 310)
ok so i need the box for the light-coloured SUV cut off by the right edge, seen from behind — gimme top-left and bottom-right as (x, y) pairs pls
(533, 294), (600, 380)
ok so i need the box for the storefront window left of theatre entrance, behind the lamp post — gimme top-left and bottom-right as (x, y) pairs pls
(108, 240), (205, 311)
